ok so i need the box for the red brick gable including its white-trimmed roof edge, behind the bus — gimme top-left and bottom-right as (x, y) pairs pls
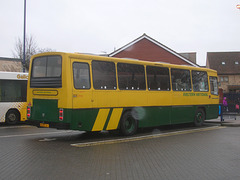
(109, 34), (198, 67)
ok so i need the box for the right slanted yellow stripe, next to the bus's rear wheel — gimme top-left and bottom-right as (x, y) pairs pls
(106, 108), (123, 130)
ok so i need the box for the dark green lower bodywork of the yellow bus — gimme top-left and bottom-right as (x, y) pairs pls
(30, 99), (218, 131)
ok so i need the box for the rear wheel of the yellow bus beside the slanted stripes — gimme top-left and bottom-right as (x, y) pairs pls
(120, 111), (138, 136)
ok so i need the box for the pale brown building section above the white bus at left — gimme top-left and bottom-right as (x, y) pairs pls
(0, 60), (22, 72)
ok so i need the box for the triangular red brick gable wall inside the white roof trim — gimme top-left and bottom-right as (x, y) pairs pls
(113, 39), (190, 65)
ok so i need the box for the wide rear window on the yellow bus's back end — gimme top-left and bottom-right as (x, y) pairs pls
(32, 56), (62, 77)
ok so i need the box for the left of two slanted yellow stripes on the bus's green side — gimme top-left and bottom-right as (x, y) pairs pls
(92, 109), (110, 131)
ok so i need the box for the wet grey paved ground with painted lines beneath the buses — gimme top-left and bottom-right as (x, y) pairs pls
(0, 116), (240, 180)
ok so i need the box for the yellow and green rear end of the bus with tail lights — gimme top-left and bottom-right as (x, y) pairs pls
(27, 53), (72, 129)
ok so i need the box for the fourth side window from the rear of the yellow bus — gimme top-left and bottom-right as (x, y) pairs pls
(147, 66), (170, 91)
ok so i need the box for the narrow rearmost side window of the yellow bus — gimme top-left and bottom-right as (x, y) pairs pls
(73, 62), (90, 89)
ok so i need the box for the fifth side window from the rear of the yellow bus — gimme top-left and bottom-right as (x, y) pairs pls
(171, 69), (192, 91)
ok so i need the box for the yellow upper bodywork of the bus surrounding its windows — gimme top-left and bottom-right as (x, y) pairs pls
(28, 53), (218, 110)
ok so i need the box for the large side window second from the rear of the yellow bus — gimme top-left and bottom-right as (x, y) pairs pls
(92, 61), (117, 90)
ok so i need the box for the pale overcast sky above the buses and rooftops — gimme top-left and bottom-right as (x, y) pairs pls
(0, 0), (240, 65)
